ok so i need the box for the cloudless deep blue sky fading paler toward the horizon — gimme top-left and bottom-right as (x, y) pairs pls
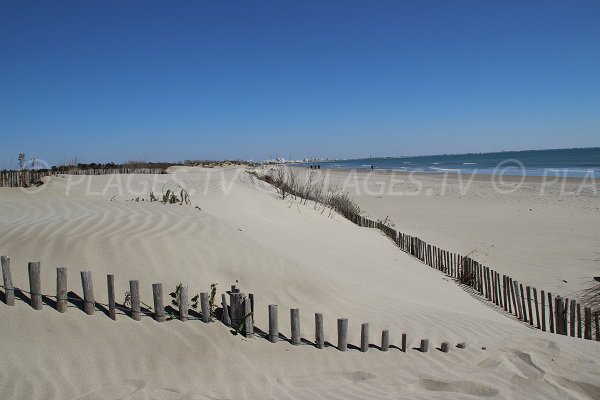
(0, 0), (600, 167)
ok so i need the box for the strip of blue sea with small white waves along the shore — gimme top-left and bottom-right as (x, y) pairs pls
(304, 147), (600, 178)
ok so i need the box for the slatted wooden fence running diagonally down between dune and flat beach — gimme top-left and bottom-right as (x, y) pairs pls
(344, 209), (600, 341)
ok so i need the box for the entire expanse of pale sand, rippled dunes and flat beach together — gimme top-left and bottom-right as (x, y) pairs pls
(0, 168), (600, 400)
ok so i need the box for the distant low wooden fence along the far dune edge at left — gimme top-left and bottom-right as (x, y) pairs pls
(0, 168), (164, 187)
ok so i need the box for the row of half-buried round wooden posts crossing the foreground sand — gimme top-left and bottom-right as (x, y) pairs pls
(0, 256), (466, 353)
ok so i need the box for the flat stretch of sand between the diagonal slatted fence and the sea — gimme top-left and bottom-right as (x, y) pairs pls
(324, 170), (600, 298)
